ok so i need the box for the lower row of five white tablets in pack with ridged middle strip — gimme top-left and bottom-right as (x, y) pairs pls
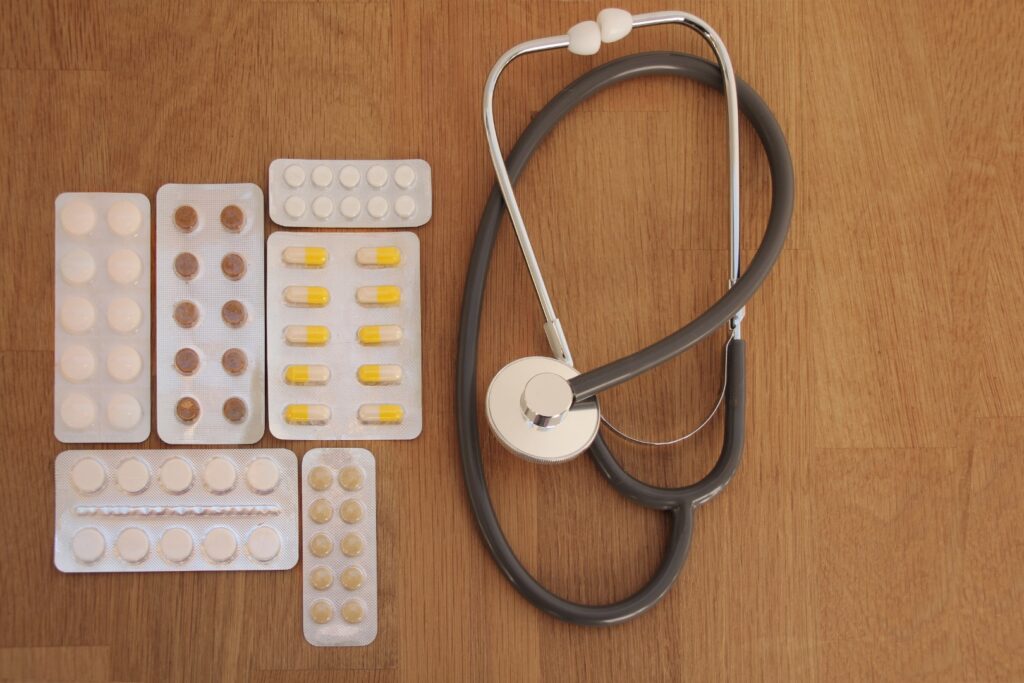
(72, 526), (281, 564)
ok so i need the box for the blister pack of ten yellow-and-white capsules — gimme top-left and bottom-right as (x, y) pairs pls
(266, 230), (423, 440)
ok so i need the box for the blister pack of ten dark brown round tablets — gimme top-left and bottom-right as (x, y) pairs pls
(156, 183), (266, 443)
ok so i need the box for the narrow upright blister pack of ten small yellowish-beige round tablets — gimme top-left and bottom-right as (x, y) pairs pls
(302, 449), (378, 647)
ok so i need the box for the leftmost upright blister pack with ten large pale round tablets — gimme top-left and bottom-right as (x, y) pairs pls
(53, 193), (150, 443)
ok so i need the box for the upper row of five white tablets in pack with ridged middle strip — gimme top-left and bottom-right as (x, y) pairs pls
(71, 456), (281, 495)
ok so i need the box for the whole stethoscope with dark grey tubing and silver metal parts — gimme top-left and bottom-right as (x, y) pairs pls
(456, 9), (793, 625)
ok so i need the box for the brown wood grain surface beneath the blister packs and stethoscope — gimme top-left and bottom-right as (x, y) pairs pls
(0, 0), (1024, 682)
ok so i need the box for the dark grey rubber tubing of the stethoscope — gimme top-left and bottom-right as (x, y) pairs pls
(456, 52), (794, 626)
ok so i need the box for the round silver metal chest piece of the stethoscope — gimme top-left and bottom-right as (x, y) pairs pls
(486, 355), (601, 463)
